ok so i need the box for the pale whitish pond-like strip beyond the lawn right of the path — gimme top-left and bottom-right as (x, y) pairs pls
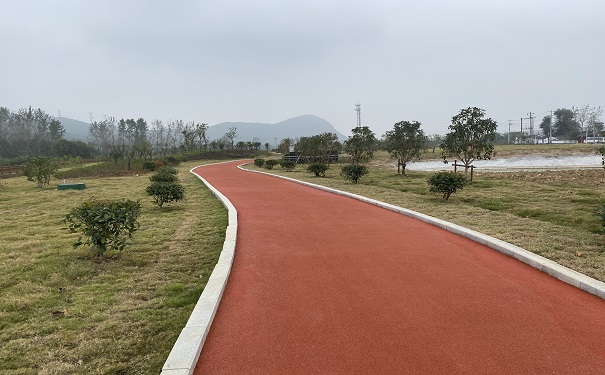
(407, 155), (602, 172)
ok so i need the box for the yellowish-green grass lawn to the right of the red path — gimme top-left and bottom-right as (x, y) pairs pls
(247, 150), (605, 281)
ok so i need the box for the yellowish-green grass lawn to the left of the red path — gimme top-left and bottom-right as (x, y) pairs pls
(0, 162), (227, 374)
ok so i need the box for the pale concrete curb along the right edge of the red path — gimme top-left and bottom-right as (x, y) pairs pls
(238, 164), (605, 299)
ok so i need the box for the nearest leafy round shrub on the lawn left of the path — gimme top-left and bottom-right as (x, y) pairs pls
(64, 198), (141, 258)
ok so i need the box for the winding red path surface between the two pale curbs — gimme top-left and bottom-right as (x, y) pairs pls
(196, 163), (605, 375)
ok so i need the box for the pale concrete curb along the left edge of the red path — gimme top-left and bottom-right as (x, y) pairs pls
(162, 163), (237, 375)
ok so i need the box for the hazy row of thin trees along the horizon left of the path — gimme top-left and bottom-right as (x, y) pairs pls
(0, 107), (252, 162)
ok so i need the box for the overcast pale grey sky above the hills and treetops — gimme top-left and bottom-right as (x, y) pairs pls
(0, 0), (605, 136)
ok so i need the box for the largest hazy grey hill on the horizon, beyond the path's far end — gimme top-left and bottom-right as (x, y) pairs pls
(206, 115), (347, 145)
